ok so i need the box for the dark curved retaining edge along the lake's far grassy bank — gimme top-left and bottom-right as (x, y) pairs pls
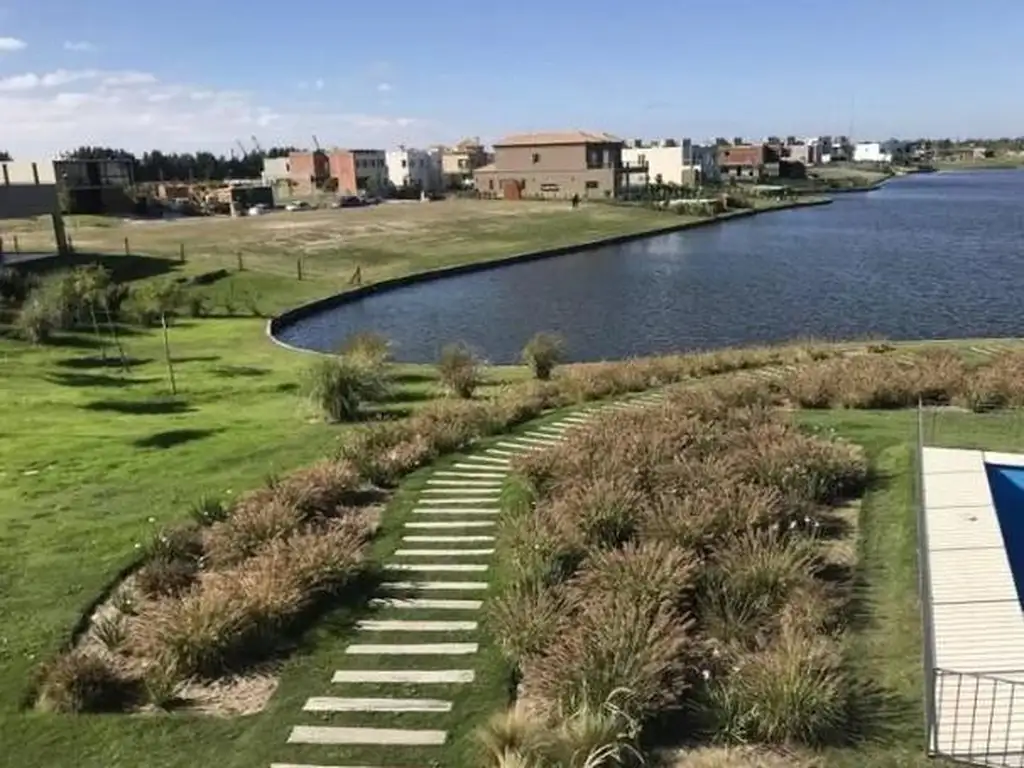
(266, 198), (833, 355)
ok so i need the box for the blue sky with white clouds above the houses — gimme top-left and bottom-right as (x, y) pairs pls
(0, 0), (1024, 159)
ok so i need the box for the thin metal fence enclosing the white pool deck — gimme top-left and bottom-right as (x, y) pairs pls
(914, 403), (1024, 768)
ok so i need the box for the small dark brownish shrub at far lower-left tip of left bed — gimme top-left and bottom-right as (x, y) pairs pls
(38, 650), (131, 713)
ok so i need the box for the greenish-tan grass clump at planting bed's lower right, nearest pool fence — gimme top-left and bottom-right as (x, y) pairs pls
(697, 632), (849, 745)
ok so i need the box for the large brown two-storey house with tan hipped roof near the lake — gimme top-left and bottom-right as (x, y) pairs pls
(473, 131), (624, 200)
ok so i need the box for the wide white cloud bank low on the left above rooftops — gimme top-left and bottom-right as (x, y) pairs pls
(0, 69), (439, 158)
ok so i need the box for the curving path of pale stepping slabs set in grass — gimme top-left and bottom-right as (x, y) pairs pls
(271, 392), (664, 768)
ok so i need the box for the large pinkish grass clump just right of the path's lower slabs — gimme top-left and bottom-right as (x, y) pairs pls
(522, 593), (693, 719)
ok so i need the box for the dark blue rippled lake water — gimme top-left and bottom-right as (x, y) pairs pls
(282, 171), (1024, 362)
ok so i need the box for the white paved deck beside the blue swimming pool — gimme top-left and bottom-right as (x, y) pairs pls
(922, 447), (1024, 768)
